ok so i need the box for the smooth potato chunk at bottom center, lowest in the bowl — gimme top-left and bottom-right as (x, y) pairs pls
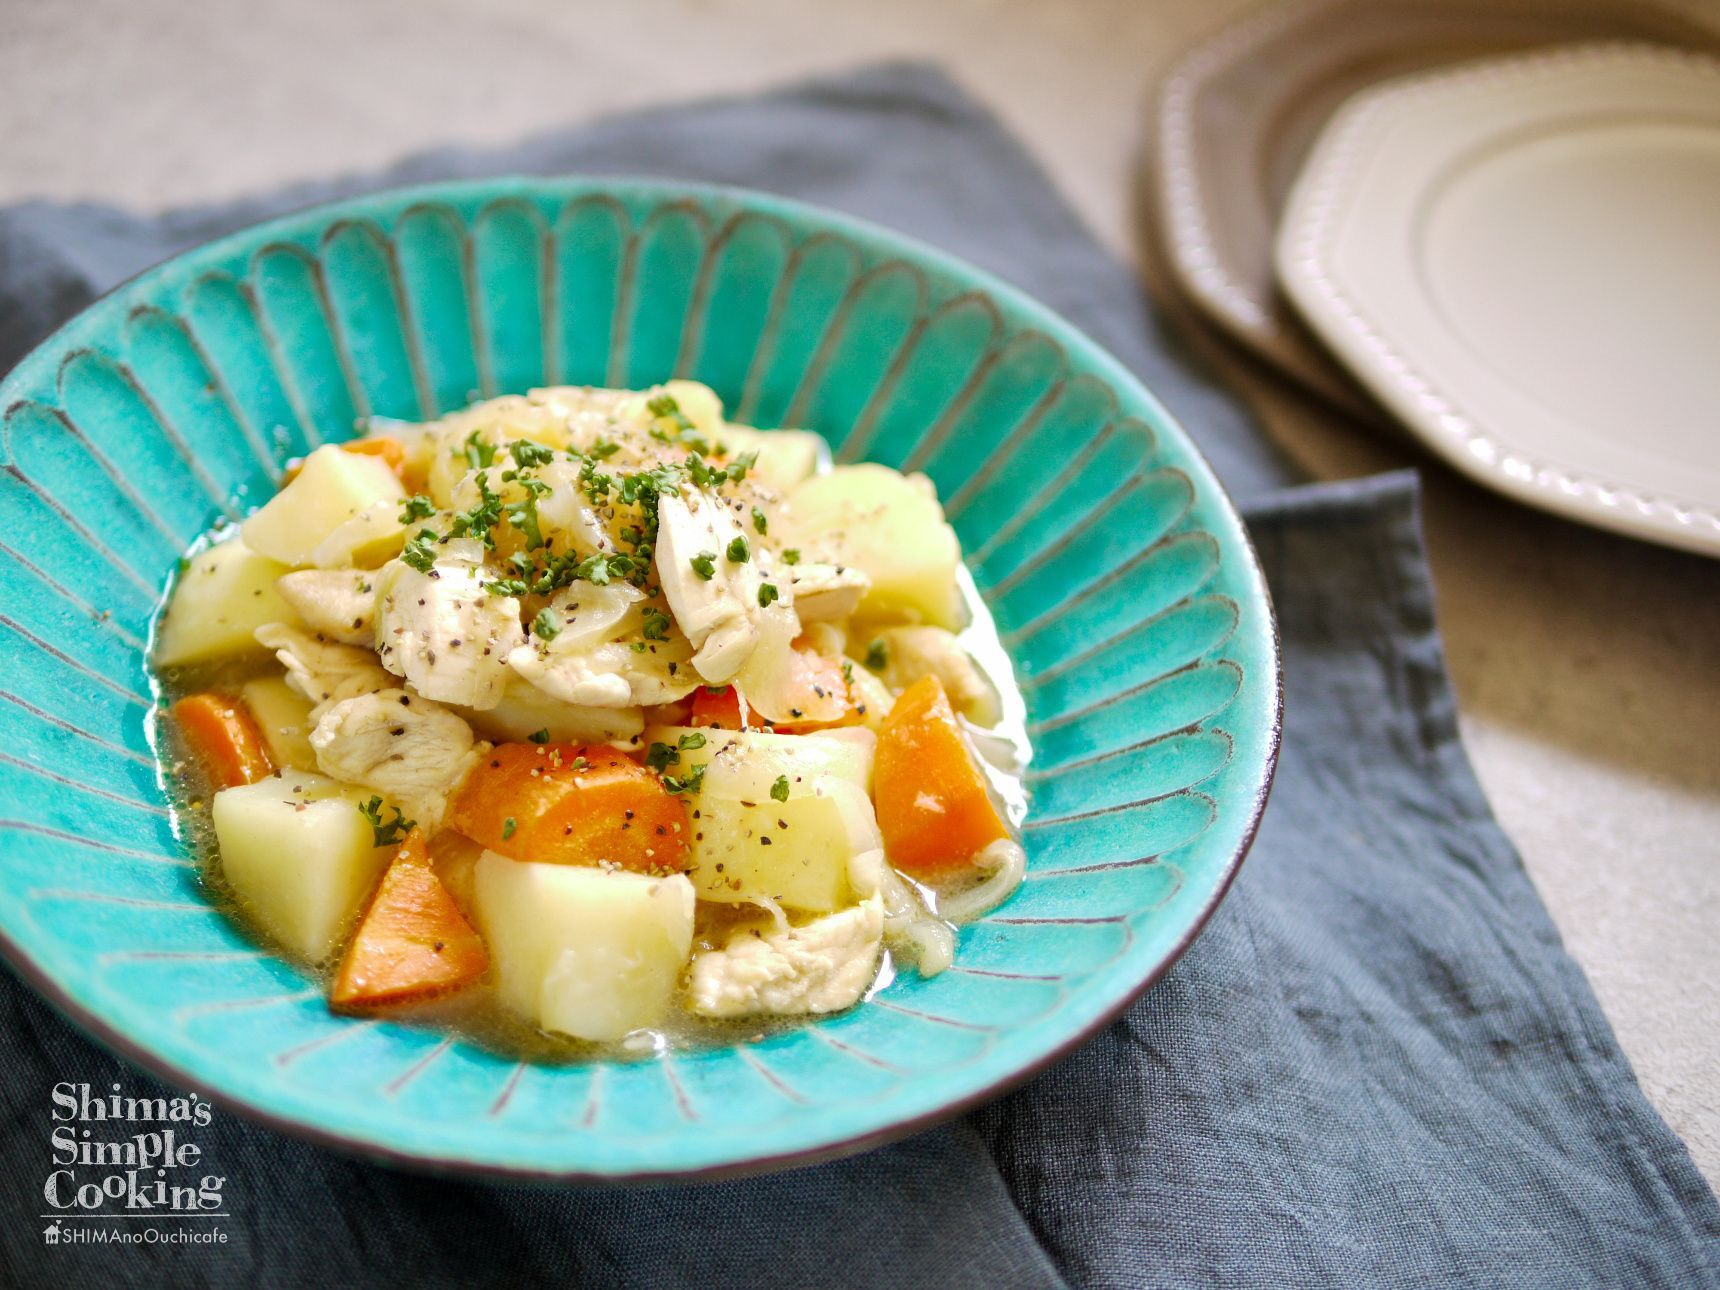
(473, 851), (695, 1041)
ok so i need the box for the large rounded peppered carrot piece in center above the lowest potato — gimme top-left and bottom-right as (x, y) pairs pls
(452, 743), (688, 874)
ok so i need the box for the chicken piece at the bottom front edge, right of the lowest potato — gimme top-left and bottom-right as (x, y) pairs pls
(688, 894), (884, 1017)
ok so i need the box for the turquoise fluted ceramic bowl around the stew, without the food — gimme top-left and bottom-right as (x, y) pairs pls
(0, 179), (1278, 1178)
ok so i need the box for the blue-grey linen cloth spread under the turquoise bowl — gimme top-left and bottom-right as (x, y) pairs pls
(0, 67), (1720, 1287)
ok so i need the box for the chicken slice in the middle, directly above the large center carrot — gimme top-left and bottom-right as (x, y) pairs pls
(507, 583), (700, 709)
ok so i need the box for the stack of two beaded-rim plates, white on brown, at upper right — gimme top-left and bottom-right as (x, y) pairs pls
(1154, 0), (1720, 556)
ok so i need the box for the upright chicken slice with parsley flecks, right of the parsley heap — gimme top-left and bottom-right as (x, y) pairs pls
(655, 492), (770, 685)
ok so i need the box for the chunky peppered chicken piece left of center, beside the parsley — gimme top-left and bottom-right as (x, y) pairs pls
(377, 540), (525, 709)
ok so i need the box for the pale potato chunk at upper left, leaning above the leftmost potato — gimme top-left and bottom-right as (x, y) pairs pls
(241, 444), (406, 568)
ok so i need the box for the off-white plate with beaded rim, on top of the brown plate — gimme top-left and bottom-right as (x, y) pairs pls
(1276, 46), (1720, 556)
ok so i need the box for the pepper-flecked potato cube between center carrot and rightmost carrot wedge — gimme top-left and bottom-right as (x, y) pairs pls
(681, 734), (882, 913)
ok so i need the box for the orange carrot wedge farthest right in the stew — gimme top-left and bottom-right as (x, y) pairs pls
(872, 676), (1010, 881)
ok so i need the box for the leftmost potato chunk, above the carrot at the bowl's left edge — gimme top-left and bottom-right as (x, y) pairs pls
(155, 537), (299, 667)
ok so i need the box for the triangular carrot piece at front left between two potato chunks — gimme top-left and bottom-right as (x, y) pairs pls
(329, 829), (490, 1010)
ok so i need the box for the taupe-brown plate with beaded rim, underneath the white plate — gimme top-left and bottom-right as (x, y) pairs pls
(1152, 0), (1720, 420)
